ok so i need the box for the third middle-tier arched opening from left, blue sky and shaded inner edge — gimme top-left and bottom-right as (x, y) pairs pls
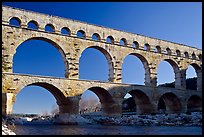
(122, 53), (150, 85)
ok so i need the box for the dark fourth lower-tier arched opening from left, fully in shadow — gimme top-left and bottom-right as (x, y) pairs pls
(158, 93), (181, 113)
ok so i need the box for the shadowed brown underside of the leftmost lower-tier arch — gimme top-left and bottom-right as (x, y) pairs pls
(16, 82), (68, 113)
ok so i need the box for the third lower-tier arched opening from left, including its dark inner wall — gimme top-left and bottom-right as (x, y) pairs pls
(122, 89), (153, 114)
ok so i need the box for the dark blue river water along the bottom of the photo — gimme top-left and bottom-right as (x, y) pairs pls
(14, 125), (202, 135)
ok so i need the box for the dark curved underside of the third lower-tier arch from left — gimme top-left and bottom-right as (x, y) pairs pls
(128, 89), (153, 114)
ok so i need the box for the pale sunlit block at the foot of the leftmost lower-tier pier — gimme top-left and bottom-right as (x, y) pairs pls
(2, 93), (16, 115)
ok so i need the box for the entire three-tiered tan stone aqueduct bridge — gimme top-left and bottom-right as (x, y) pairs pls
(2, 6), (202, 115)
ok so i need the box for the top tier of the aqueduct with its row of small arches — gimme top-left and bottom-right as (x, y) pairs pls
(2, 6), (202, 61)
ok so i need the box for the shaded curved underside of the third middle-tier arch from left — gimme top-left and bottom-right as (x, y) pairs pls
(122, 53), (151, 85)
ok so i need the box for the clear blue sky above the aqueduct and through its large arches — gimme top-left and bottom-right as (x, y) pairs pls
(3, 2), (202, 113)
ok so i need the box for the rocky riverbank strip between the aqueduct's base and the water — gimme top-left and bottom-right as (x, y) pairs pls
(2, 112), (202, 135)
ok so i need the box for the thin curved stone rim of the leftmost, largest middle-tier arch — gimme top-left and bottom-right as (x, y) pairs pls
(12, 37), (69, 77)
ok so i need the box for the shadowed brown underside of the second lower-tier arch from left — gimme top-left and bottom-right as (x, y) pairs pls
(83, 86), (115, 115)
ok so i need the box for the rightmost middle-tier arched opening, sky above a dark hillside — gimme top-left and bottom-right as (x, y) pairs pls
(186, 63), (202, 90)
